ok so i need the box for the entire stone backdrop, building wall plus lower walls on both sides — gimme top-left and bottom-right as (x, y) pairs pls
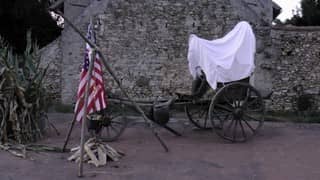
(42, 0), (320, 111)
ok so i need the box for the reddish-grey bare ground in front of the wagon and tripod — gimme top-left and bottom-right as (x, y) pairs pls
(0, 113), (320, 180)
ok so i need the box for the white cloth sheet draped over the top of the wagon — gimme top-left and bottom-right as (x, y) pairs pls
(188, 21), (256, 89)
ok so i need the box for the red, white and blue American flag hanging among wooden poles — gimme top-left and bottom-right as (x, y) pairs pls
(75, 23), (106, 121)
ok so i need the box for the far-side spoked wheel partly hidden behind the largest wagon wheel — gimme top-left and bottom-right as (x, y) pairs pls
(185, 100), (212, 129)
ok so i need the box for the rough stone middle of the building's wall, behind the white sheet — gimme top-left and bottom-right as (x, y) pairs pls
(96, 0), (271, 99)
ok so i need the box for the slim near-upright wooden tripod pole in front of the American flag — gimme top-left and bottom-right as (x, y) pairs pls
(78, 49), (96, 177)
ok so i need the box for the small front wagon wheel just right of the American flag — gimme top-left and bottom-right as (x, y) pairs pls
(99, 104), (127, 142)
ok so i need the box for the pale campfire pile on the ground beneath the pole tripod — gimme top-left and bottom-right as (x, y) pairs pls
(68, 138), (124, 167)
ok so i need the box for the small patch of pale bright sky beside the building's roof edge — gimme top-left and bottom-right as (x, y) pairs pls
(273, 0), (301, 21)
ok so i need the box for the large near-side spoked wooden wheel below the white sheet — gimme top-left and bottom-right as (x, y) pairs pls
(209, 83), (265, 142)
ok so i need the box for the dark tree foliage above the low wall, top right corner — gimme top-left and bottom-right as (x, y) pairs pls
(285, 0), (320, 26)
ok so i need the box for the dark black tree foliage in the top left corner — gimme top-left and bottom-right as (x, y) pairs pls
(0, 0), (62, 54)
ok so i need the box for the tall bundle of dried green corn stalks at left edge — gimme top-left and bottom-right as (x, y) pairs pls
(0, 32), (48, 143)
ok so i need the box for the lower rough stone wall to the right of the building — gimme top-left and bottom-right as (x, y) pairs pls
(265, 27), (320, 111)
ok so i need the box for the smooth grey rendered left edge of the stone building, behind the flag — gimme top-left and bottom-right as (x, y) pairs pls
(61, 0), (104, 104)
